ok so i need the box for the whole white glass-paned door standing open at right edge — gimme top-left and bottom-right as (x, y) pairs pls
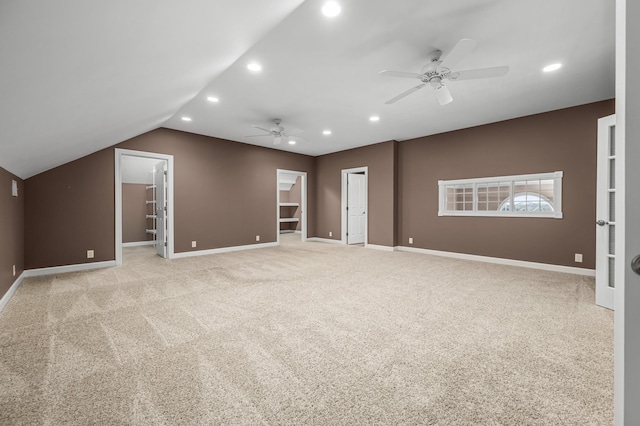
(596, 115), (616, 309)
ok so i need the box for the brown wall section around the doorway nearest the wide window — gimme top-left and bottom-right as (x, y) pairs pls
(316, 141), (397, 247)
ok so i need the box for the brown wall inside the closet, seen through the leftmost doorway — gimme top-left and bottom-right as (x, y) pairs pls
(122, 183), (152, 243)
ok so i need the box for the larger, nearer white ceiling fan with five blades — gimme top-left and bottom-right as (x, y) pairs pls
(379, 38), (509, 105)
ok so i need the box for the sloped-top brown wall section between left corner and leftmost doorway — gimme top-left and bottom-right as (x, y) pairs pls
(25, 150), (115, 269)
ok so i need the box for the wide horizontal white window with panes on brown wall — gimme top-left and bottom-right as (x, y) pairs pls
(438, 172), (562, 219)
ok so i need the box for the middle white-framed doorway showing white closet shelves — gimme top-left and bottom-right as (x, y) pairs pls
(276, 169), (307, 244)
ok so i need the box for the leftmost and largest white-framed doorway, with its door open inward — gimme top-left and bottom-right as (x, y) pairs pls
(115, 148), (174, 265)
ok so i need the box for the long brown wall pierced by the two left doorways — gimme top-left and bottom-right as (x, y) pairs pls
(25, 129), (314, 268)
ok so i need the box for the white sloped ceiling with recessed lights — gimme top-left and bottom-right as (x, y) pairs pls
(0, 0), (615, 178)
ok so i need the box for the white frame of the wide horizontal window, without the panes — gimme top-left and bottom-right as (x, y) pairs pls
(438, 172), (563, 219)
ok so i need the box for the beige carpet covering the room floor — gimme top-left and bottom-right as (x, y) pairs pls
(0, 236), (613, 425)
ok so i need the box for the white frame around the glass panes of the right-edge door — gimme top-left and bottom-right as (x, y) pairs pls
(596, 114), (620, 309)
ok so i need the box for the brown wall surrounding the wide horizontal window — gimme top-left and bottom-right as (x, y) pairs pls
(398, 100), (614, 269)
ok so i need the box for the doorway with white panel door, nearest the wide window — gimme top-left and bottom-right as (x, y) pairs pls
(342, 167), (369, 246)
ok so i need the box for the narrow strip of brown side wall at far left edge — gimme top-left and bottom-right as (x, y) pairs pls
(0, 167), (25, 298)
